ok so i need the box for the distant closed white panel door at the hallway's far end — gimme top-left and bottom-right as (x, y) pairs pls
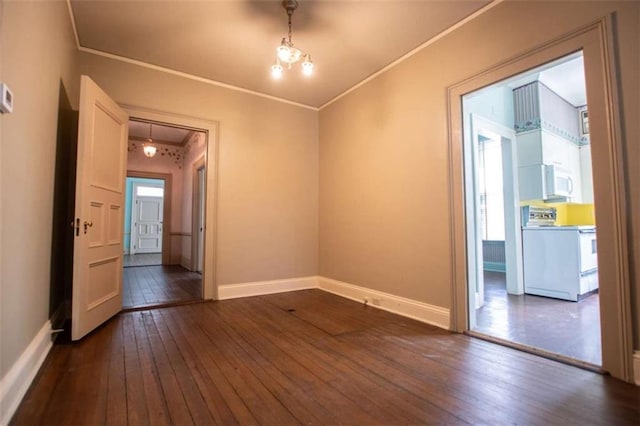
(132, 197), (164, 253)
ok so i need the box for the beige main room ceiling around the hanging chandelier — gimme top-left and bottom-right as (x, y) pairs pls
(70, 0), (491, 108)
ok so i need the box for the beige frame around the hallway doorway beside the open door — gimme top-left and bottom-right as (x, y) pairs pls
(120, 104), (220, 300)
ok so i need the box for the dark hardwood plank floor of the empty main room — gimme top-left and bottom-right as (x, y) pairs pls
(11, 290), (640, 425)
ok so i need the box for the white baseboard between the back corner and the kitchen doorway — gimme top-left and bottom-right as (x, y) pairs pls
(318, 277), (450, 330)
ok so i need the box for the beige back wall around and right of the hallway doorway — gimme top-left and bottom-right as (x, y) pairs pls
(79, 53), (318, 285)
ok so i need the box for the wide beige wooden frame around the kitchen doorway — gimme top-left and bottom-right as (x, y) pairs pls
(447, 15), (633, 382)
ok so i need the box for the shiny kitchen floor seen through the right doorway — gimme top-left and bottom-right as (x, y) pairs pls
(474, 271), (602, 366)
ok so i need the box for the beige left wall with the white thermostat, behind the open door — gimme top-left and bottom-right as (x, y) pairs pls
(0, 1), (79, 376)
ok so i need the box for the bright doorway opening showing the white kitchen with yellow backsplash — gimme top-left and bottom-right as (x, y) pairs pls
(462, 52), (602, 369)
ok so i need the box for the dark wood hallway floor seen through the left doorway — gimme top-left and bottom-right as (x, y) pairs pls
(122, 265), (202, 309)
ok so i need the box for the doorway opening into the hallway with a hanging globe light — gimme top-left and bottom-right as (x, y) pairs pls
(123, 118), (207, 309)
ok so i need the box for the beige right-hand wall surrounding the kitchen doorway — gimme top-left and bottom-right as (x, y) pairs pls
(319, 1), (640, 348)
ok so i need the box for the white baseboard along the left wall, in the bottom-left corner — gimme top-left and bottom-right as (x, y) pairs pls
(0, 320), (53, 425)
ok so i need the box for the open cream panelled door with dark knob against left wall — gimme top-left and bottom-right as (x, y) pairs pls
(71, 75), (129, 340)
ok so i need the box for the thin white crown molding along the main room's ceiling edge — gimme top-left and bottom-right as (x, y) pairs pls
(66, 0), (504, 111)
